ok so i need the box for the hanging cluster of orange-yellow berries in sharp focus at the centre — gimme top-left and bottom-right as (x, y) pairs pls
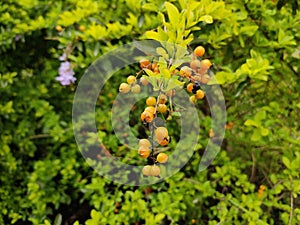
(119, 46), (212, 177)
